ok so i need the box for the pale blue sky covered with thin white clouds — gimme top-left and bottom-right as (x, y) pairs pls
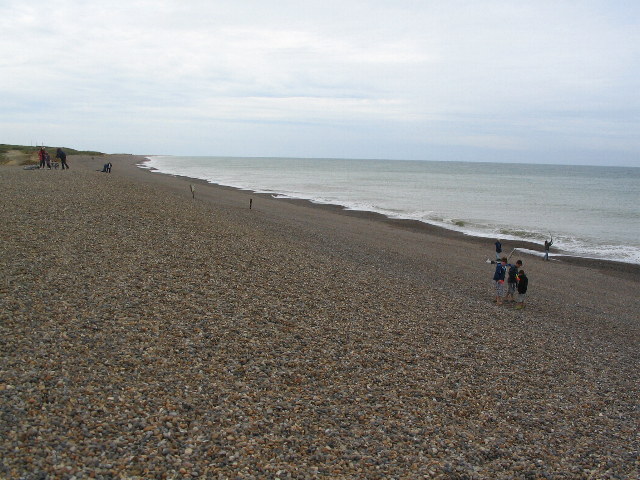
(0, 0), (640, 167)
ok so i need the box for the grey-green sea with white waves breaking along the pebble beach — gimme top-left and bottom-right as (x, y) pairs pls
(141, 156), (640, 264)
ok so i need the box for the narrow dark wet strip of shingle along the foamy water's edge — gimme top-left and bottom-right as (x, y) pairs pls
(138, 155), (640, 281)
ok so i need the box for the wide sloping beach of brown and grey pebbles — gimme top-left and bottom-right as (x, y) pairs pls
(0, 155), (640, 479)
